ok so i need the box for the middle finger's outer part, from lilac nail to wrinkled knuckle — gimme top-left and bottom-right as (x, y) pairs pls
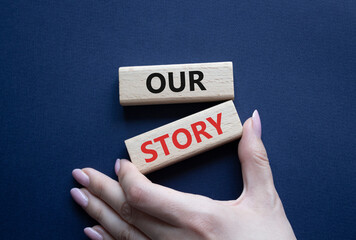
(72, 168), (126, 214)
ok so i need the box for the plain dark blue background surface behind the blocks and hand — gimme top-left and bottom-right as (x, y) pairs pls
(0, 0), (356, 239)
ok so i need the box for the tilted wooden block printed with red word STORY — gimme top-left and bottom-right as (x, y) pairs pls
(125, 100), (242, 174)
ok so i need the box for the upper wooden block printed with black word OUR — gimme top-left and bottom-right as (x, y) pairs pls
(119, 62), (234, 106)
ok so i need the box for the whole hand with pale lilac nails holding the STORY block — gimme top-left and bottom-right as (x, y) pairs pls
(71, 111), (296, 240)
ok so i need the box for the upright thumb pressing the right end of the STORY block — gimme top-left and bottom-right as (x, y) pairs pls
(238, 110), (275, 196)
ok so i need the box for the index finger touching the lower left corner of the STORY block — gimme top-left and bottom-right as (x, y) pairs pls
(115, 160), (214, 226)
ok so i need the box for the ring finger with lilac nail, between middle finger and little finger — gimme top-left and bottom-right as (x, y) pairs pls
(71, 188), (148, 240)
